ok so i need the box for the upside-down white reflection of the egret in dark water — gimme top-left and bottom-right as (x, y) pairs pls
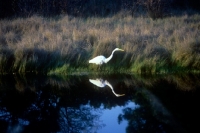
(89, 78), (125, 97)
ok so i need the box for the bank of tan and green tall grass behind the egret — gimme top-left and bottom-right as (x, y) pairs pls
(0, 13), (200, 74)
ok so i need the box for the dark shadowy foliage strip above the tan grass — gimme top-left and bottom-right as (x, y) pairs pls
(0, 0), (200, 18)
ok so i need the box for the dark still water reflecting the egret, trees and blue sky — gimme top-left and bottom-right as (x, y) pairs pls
(0, 74), (200, 133)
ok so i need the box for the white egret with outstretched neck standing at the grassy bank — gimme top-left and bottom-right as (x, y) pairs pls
(89, 48), (124, 65)
